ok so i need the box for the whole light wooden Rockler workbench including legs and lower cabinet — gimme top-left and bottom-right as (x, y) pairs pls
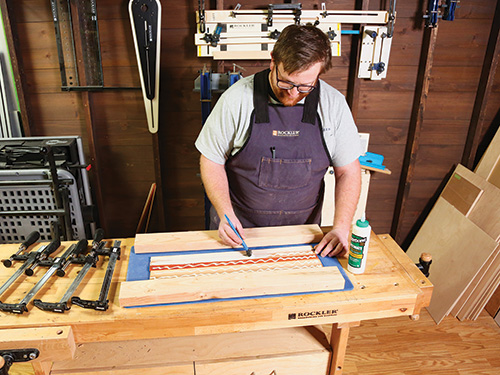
(0, 234), (433, 375)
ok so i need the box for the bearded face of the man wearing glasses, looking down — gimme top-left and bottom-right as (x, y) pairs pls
(269, 60), (321, 107)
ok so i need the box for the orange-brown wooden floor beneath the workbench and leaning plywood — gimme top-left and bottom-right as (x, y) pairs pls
(10, 310), (500, 375)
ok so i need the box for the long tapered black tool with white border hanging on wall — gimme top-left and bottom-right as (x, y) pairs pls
(128, 0), (161, 133)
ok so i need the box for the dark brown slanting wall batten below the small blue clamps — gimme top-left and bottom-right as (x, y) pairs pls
(391, 26), (438, 243)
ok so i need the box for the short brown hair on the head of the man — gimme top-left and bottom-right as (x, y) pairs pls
(272, 25), (332, 73)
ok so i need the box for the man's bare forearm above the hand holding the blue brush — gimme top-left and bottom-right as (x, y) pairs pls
(200, 155), (234, 218)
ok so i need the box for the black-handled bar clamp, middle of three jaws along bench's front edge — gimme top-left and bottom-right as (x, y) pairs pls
(33, 229), (105, 313)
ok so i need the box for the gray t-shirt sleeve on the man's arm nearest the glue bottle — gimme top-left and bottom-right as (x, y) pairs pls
(332, 96), (361, 167)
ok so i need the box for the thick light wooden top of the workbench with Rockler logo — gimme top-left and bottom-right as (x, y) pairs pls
(0, 233), (433, 343)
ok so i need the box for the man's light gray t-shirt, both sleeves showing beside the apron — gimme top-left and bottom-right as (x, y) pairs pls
(195, 75), (361, 167)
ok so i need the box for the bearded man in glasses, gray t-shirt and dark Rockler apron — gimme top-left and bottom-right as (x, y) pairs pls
(196, 25), (361, 256)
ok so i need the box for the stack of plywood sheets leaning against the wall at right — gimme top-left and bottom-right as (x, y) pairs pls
(407, 128), (500, 323)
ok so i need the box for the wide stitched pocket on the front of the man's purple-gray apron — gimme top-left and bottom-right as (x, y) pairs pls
(259, 157), (312, 190)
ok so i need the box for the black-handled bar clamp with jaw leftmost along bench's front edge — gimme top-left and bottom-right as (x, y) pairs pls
(0, 240), (87, 314)
